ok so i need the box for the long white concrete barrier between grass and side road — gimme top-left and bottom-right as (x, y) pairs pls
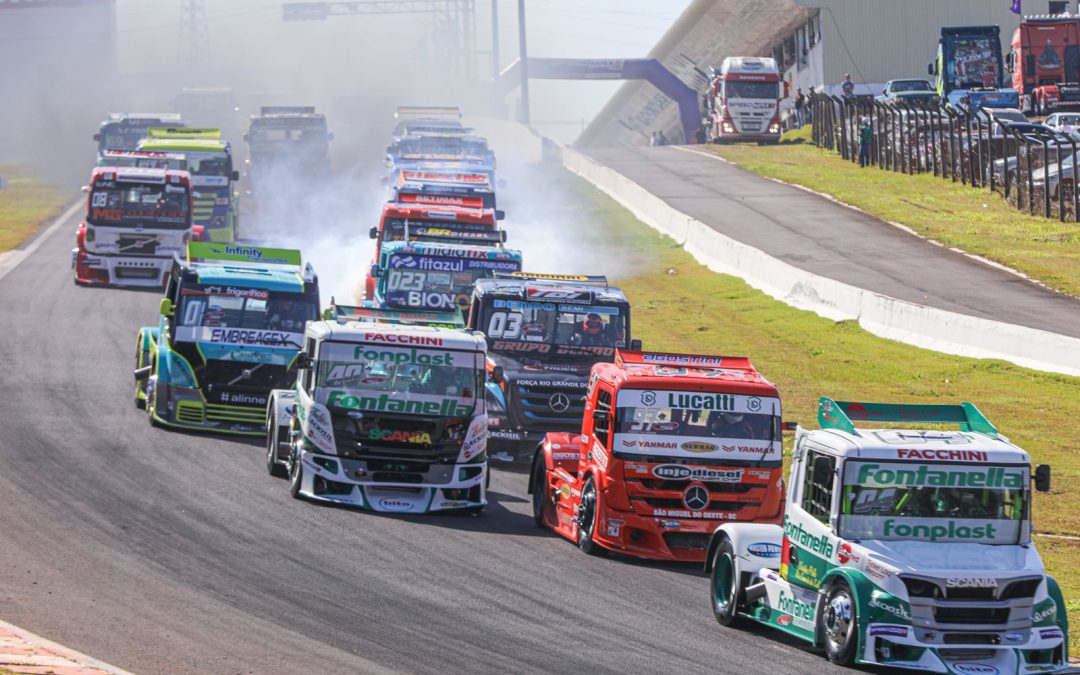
(562, 148), (1080, 376)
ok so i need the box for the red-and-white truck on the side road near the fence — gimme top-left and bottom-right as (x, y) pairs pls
(705, 56), (788, 144)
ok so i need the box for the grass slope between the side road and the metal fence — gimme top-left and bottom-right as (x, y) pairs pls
(708, 127), (1080, 296)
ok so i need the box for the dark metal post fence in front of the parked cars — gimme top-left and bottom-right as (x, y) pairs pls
(810, 94), (1080, 222)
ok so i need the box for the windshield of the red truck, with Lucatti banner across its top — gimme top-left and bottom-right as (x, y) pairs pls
(612, 388), (781, 463)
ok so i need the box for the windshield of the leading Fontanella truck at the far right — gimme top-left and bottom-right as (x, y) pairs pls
(840, 460), (1030, 544)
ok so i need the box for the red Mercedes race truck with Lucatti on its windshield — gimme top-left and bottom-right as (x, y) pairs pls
(528, 350), (783, 562)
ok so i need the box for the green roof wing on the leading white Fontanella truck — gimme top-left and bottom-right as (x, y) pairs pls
(818, 396), (998, 438)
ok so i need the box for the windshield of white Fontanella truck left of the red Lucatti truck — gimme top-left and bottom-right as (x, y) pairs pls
(315, 342), (484, 417)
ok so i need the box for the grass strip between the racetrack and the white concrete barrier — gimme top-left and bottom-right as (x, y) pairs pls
(537, 160), (1080, 649)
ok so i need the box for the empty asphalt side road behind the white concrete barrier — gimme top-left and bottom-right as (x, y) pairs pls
(590, 147), (1080, 337)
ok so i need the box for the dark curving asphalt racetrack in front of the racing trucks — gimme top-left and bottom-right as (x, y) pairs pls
(0, 162), (864, 675)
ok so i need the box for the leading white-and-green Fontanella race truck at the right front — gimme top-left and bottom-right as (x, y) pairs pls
(706, 397), (1068, 675)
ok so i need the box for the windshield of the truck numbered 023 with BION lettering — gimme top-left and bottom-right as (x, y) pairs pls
(379, 249), (522, 310)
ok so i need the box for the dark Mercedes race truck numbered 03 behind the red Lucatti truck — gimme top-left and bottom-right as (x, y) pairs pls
(469, 273), (636, 467)
